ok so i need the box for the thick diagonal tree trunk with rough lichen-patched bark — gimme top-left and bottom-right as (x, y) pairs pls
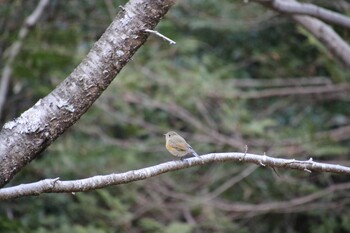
(0, 0), (175, 187)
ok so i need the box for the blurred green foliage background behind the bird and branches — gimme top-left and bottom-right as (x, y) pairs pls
(0, 0), (350, 233)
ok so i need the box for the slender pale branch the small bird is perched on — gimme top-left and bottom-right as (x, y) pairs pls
(0, 152), (350, 200)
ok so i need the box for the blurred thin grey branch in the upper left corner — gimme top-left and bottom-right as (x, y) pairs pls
(0, 0), (49, 117)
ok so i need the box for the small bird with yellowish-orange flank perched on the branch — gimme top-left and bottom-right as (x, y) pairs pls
(164, 131), (199, 158)
